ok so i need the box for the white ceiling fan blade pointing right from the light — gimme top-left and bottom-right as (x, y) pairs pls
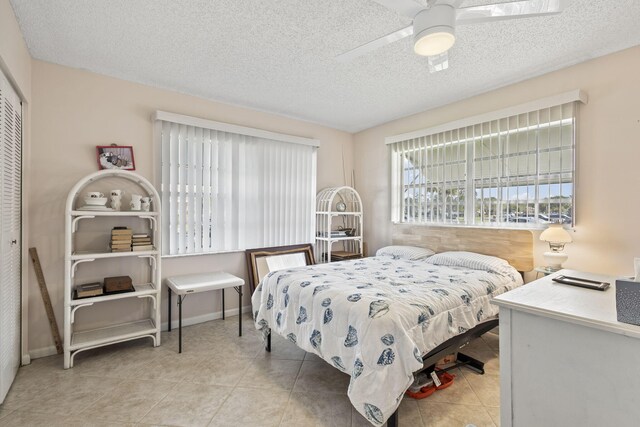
(456, 0), (565, 25)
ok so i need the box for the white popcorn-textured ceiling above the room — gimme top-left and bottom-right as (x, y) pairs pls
(11, 0), (640, 132)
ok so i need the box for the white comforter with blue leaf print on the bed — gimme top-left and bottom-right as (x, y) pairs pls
(252, 257), (522, 425)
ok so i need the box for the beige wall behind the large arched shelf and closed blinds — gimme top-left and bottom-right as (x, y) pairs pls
(28, 60), (353, 356)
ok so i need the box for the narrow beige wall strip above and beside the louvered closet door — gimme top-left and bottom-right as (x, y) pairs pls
(0, 0), (31, 363)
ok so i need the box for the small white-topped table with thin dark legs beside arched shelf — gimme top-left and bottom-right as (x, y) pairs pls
(167, 271), (244, 353)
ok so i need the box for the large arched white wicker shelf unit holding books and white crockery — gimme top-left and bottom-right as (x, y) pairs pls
(64, 170), (162, 369)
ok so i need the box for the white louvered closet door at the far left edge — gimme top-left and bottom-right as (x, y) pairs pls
(0, 72), (22, 403)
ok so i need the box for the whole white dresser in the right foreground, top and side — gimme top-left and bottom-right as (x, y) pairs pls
(493, 270), (640, 427)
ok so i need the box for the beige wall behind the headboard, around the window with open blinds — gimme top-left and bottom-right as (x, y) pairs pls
(354, 47), (640, 280)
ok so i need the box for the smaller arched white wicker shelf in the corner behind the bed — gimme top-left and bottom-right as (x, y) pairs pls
(315, 186), (364, 262)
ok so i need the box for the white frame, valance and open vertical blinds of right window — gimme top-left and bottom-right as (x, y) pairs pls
(385, 90), (588, 229)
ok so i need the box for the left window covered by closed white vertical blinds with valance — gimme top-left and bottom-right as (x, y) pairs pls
(155, 112), (318, 255)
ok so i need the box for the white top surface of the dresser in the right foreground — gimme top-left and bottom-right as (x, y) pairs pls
(492, 270), (640, 339)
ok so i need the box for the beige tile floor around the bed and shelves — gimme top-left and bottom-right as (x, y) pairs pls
(0, 317), (500, 427)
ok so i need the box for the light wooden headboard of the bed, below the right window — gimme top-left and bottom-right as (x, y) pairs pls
(392, 224), (533, 271)
